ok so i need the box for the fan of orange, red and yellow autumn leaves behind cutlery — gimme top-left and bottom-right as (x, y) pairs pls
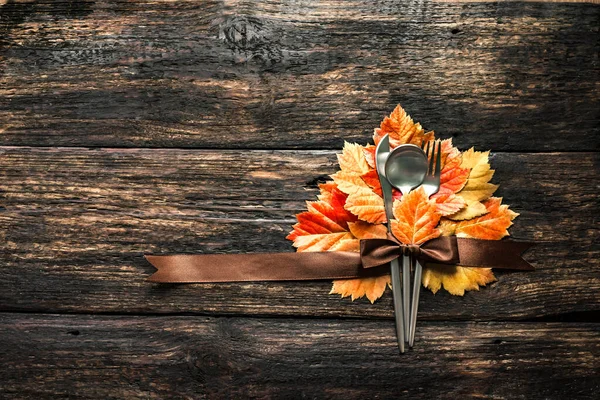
(287, 105), (519, 303)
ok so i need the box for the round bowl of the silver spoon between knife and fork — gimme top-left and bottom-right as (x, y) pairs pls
(385, 144), (428, 196)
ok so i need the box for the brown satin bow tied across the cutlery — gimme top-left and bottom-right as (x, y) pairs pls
(360, 234), (460, 268)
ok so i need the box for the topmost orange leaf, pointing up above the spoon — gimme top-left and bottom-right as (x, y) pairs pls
(373, 105), (434, 148)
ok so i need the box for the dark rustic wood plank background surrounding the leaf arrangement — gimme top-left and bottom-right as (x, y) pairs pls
(0, 0), (600, 399)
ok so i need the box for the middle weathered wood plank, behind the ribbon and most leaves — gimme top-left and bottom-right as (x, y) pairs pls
(0, 148), (600, 320)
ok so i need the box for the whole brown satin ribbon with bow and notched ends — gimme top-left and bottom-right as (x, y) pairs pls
(145, 236), (534, 283)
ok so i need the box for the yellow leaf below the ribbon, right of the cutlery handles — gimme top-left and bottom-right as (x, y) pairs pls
(421, 264), (496, 296)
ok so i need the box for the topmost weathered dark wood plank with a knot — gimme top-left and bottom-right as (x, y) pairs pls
(0, 0), (600, 151)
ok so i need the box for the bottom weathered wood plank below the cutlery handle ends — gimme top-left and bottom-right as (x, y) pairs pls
(0, 314), (600, 400)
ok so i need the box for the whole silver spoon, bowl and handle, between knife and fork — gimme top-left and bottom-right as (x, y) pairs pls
(385, 144), (428, 338)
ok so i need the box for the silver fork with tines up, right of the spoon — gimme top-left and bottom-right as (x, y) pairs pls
(408, 141), (442, 347)
